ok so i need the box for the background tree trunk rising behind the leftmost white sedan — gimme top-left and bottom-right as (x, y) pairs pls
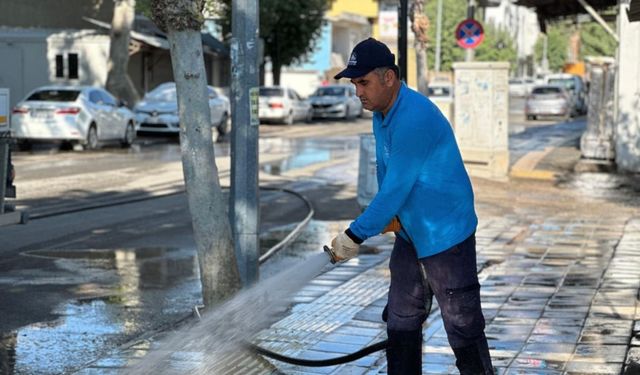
(106, 0), (140, 106)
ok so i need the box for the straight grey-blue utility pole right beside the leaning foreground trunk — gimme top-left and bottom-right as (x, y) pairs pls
(229, 0), (260, 286)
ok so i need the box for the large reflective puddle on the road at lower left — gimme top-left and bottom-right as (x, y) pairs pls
(0, 248), (200, 374)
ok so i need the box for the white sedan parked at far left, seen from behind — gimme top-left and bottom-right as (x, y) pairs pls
(11, 86), (136, 149)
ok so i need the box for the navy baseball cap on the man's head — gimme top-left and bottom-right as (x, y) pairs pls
(333, 38), (397, 79)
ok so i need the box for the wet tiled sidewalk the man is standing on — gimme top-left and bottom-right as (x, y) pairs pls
(79, 134), (640, 375)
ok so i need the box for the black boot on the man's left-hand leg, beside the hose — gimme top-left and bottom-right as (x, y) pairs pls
(387, 329), (422, 375)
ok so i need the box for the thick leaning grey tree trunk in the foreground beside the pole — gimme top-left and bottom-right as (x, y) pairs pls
(152, 0), (241, 306)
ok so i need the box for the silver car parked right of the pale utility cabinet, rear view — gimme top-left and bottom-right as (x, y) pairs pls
(524, 85), (572, 120)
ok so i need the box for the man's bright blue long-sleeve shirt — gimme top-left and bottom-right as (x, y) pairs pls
(349, 84), (478, 258)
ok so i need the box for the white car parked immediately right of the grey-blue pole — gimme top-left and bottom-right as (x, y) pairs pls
(258, 86), (313, 125)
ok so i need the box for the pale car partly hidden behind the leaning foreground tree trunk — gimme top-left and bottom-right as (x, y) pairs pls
(133, 82), (231, 139)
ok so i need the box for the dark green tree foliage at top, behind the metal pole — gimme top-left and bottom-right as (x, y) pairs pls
(220, 0), (330, 82)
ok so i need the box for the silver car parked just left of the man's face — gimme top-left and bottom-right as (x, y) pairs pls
(309, 85), (362, 119)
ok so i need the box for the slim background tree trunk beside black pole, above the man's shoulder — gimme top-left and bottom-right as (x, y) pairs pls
(409, 0), (429, 95)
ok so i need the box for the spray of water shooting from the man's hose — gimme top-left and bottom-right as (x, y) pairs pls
(126, 253), (329, 375)
